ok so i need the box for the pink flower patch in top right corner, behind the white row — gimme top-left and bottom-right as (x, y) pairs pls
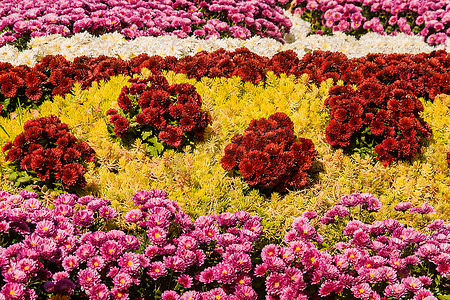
(291, 0), (450, 44)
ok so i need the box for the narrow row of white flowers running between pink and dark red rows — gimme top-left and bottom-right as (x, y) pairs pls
(0, 12), (450, 66)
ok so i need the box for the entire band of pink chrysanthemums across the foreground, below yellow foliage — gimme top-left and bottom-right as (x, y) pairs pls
(0, 189), (450, 300)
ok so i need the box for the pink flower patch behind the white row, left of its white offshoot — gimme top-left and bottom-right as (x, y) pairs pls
(0, 0), (292, 46)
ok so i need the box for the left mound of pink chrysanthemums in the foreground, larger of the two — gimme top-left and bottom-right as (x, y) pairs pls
(0, 189), (262, 299)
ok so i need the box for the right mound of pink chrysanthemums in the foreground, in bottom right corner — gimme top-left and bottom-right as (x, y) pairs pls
(255, 193), (450, 299)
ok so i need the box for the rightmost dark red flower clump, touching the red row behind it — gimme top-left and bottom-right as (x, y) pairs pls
(325, 78), (431, 165)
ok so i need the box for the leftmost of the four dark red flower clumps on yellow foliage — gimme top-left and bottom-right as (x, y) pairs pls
(2, 115), (95, 188)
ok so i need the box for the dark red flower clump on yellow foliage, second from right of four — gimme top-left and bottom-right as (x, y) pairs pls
(220, 112), (317, 192)
